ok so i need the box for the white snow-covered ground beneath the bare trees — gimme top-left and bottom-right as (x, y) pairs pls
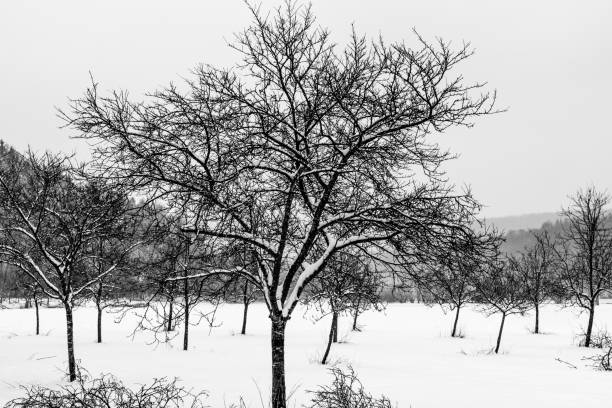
(0, 304), (612, 408)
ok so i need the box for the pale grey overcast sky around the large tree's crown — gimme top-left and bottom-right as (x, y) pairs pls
(0, 0), (612, 216)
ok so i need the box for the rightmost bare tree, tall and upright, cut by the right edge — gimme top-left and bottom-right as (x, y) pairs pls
(556, 187), (612, 347)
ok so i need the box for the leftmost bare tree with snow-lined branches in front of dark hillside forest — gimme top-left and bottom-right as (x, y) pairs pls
(0, 153), (143, 381)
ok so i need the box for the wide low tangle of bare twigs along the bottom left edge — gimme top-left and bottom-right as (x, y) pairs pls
(5, 375), (206, 408)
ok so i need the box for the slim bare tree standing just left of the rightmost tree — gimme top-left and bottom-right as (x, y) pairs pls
(510, 231), (559, 334)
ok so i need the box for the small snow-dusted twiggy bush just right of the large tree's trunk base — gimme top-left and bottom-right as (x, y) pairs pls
(310, 367), (392, 408)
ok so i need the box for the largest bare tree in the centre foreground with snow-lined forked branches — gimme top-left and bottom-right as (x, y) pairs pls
(64, 2), (494, 408)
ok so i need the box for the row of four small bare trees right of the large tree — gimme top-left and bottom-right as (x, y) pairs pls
(411, 187), (612, 352)
